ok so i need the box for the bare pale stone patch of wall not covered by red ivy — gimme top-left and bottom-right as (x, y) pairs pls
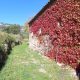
(29, 33), (52, 54)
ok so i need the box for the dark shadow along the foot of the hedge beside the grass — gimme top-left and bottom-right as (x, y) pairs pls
(0, 42), (20, 71)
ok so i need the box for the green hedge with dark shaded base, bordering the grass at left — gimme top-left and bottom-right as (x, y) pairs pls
(0, 32), (19, 68)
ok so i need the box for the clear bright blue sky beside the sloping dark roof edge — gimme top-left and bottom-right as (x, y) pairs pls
(0, 0), (49, 25)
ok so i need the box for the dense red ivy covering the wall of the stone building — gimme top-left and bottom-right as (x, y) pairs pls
(30, 0), (80, 68)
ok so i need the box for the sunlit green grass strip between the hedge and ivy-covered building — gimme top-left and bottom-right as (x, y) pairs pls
(0, 43), (74, 80)
